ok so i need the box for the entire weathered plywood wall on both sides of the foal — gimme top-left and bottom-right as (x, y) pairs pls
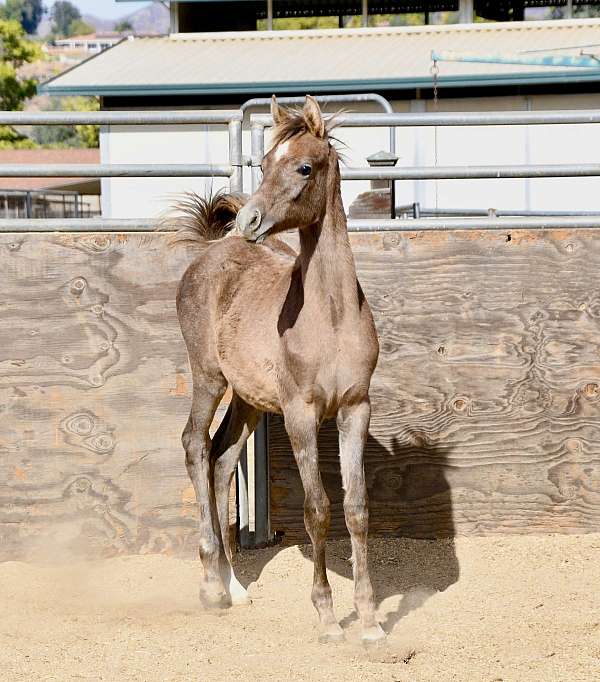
(0, 231), (600, 560)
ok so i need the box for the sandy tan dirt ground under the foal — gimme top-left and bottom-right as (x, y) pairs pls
(0, 535), (600, 682)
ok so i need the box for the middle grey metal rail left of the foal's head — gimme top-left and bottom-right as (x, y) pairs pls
(0, 163), (233, 178)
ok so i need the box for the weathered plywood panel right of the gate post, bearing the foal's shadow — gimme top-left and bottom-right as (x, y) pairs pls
(269, 231), (600, 542)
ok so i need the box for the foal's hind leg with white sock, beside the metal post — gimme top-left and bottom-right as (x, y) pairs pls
(211, 393), (260, 604)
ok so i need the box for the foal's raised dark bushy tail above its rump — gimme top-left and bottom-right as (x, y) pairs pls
(161, 191), (248, 245)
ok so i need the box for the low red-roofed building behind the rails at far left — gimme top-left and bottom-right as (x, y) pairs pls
(0, 149), (100, 218)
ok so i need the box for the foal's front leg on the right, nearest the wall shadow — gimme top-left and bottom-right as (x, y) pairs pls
(337, 398), (385, 642)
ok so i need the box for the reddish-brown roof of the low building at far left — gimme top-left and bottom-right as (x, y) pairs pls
(0, 149), (100, 194)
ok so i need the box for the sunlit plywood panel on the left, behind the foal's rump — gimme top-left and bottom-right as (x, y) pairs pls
(0, 233), (231, 560)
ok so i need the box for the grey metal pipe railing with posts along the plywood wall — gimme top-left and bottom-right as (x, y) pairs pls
(0, 110), (600, 546)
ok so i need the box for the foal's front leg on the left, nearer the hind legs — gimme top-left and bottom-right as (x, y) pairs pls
(284, 403), (344, 642)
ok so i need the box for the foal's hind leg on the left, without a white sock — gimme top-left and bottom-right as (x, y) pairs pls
(181, 363), (228, 607)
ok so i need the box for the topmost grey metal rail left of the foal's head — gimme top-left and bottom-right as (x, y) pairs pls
(0, 109), (243, 126)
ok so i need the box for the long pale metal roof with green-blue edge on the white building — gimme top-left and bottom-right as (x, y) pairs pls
(40, 19), (600, 96)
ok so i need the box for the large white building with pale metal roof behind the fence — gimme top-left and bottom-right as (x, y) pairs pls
(41, 0), (600, 217)
